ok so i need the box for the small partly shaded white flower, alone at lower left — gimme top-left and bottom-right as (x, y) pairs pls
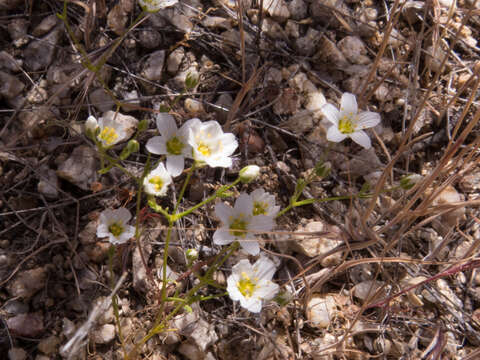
(97, 208), (135, 244)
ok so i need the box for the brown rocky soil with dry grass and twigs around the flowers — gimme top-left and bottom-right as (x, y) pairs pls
(0, 0), (480, 360)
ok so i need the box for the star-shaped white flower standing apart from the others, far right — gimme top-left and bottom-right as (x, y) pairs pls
(322, 93), (380, 149)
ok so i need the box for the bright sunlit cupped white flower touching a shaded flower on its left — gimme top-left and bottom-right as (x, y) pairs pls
(188, 121), (238, 167)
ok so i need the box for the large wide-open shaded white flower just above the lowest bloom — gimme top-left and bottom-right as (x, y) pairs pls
(213, 193), (274, 255)
